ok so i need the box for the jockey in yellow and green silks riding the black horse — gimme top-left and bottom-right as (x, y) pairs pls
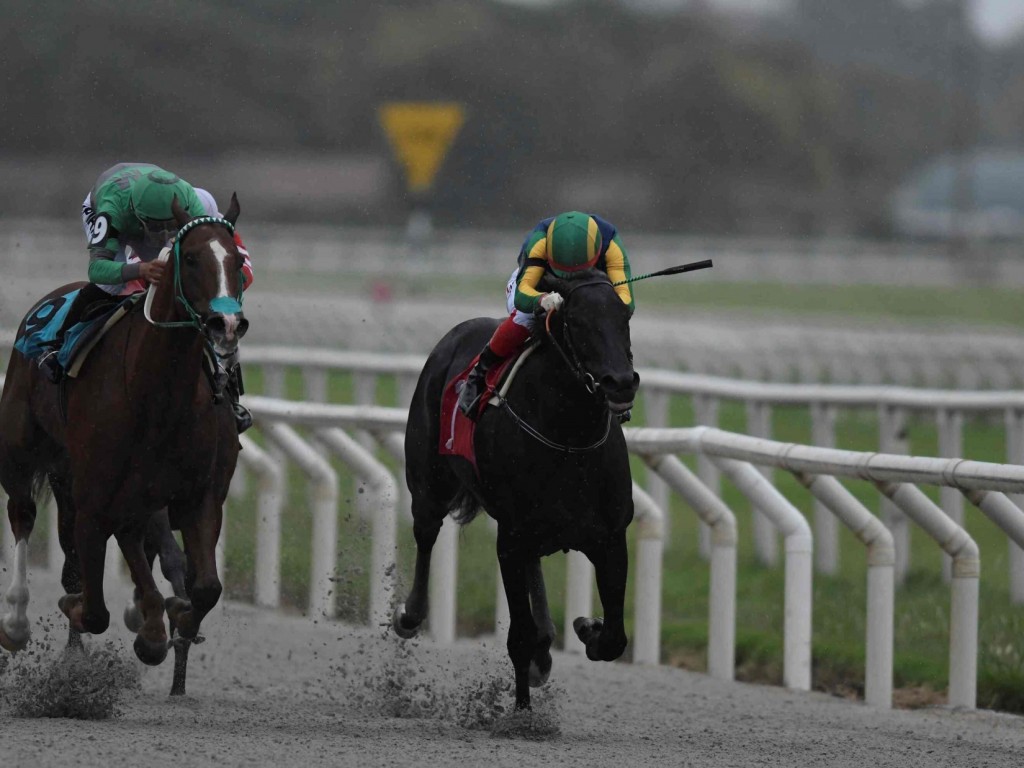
(459, 211), (635, 419)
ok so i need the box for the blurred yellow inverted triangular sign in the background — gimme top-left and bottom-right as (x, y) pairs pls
(379, 101), (466, 193)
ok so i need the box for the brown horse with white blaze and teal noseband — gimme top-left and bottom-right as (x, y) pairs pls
(0, 196), (248, 679)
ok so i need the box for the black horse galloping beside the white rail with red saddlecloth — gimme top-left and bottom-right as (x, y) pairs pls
(392, 270), (639, 709)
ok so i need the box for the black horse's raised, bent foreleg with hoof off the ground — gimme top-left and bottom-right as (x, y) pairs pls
(572, 534), (629, 662)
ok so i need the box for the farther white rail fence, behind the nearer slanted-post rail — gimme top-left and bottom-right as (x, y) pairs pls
(234, 347), (1024, 604)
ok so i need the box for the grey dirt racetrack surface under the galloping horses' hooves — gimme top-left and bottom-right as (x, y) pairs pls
(0, 572), (1024, 768)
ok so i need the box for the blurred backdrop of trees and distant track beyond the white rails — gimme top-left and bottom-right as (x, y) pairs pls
(0, 0), (1024, 379)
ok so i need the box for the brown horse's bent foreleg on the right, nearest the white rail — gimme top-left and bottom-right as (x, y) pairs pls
(167, 500), (223, 640)
